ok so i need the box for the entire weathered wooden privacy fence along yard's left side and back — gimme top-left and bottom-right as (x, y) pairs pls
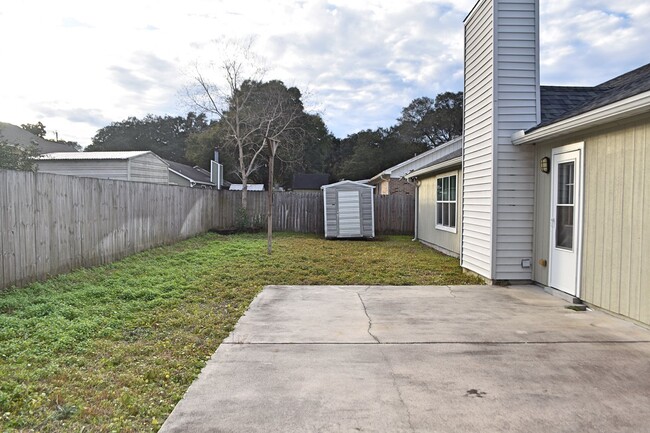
(0, 170), (414, 289)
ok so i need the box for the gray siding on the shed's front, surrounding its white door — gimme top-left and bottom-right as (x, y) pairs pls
(323, 184), (375, 238)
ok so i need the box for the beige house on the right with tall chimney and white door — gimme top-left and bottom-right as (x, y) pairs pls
(411, 0), (650, 324)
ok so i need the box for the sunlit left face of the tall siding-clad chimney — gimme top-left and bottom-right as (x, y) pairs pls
(458, 0), (494, 278)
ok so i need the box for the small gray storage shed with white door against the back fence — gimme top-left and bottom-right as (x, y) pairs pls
(321, 180), (375, 238)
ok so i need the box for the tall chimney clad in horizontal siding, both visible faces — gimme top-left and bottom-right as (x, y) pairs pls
(461, 0), (540, 280)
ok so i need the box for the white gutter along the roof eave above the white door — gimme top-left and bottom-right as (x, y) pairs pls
(511, 92), (650, 146)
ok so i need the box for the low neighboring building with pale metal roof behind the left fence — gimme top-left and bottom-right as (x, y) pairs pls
(38, 151), (169, 184)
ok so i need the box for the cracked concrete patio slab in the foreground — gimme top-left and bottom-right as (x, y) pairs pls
(160, 286), (650, 433)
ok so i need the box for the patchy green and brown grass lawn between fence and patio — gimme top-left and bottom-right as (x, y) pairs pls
(0, 233), (480, 432)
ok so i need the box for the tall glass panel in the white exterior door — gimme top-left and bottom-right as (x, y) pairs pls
(555, 161), (575, 250)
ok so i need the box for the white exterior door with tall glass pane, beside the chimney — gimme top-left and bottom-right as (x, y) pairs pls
(549, 144), (583, 296)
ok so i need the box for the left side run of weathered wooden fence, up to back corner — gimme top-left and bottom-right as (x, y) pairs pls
(0, 170), (217, 287)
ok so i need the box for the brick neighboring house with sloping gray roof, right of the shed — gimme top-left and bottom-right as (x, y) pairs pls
(368, 137), (462, 195)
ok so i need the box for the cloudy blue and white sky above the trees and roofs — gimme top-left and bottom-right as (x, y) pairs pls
(0, 0), (650, 145)
